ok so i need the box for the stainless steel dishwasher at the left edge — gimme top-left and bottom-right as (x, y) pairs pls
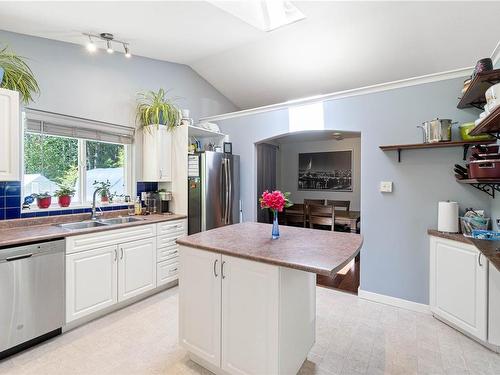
(0, 239), (65, 359)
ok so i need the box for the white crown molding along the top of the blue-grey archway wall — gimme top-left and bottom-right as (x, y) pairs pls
(200, 65), (472, 122)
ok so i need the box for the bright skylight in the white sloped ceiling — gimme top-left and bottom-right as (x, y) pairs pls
(208, 0), (306, 31)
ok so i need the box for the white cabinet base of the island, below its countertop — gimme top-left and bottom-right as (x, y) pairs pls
(179, 246), (316, 375)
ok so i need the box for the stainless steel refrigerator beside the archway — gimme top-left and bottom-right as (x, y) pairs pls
(188, 151), (240, 234)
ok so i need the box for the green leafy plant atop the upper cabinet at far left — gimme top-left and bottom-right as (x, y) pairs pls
(0, 47), (40, 105)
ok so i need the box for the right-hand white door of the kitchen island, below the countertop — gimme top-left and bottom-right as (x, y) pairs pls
(221, 255), (279, 375)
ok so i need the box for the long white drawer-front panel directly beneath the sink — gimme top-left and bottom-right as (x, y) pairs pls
(66, 224), (156, 254)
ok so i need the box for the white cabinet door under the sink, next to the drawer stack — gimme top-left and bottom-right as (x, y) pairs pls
(118, 237), (156, 301)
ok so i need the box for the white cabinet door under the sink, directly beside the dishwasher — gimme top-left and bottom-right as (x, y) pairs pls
(66, 246), (117, 322)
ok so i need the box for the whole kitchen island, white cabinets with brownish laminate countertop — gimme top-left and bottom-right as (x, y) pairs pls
(177, 223), (362, 375)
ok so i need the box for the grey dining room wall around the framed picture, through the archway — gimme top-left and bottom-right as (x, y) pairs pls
(277, 138), (361, 210)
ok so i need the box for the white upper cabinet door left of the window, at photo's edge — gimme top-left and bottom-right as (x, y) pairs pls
(0, 89), (21, 181)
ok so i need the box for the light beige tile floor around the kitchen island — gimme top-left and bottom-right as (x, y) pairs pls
(0, 288), (500, 375)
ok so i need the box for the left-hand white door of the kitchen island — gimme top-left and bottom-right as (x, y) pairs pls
(179, 246), (221, 367)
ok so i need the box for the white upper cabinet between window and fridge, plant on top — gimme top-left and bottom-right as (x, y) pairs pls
(142, 125), (172, 182)
